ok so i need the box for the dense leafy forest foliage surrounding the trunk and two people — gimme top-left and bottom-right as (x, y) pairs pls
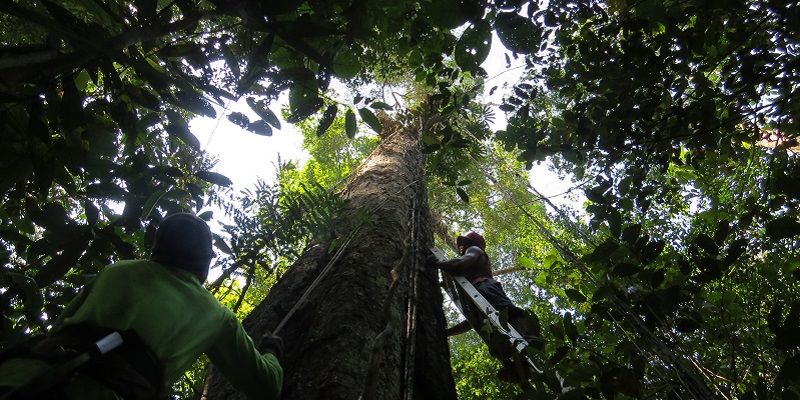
(0, 0), (800, 399)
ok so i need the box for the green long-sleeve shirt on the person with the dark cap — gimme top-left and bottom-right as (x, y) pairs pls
(0, 260), (283, 399)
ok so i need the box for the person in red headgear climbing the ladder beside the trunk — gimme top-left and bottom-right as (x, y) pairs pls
(428, 231), (543, 381)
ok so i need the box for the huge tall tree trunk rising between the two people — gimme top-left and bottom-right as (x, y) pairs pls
(206, 117), (456, 400)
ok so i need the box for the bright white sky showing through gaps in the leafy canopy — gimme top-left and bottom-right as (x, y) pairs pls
(190, 36), (580, 211)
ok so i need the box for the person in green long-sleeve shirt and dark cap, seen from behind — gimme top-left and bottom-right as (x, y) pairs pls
(0, 213), (283, 399)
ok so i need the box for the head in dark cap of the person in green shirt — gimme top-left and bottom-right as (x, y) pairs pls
(150, 213), (214, 282)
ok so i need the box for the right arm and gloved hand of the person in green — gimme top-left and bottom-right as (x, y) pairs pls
(206, 314), (283, 400)
